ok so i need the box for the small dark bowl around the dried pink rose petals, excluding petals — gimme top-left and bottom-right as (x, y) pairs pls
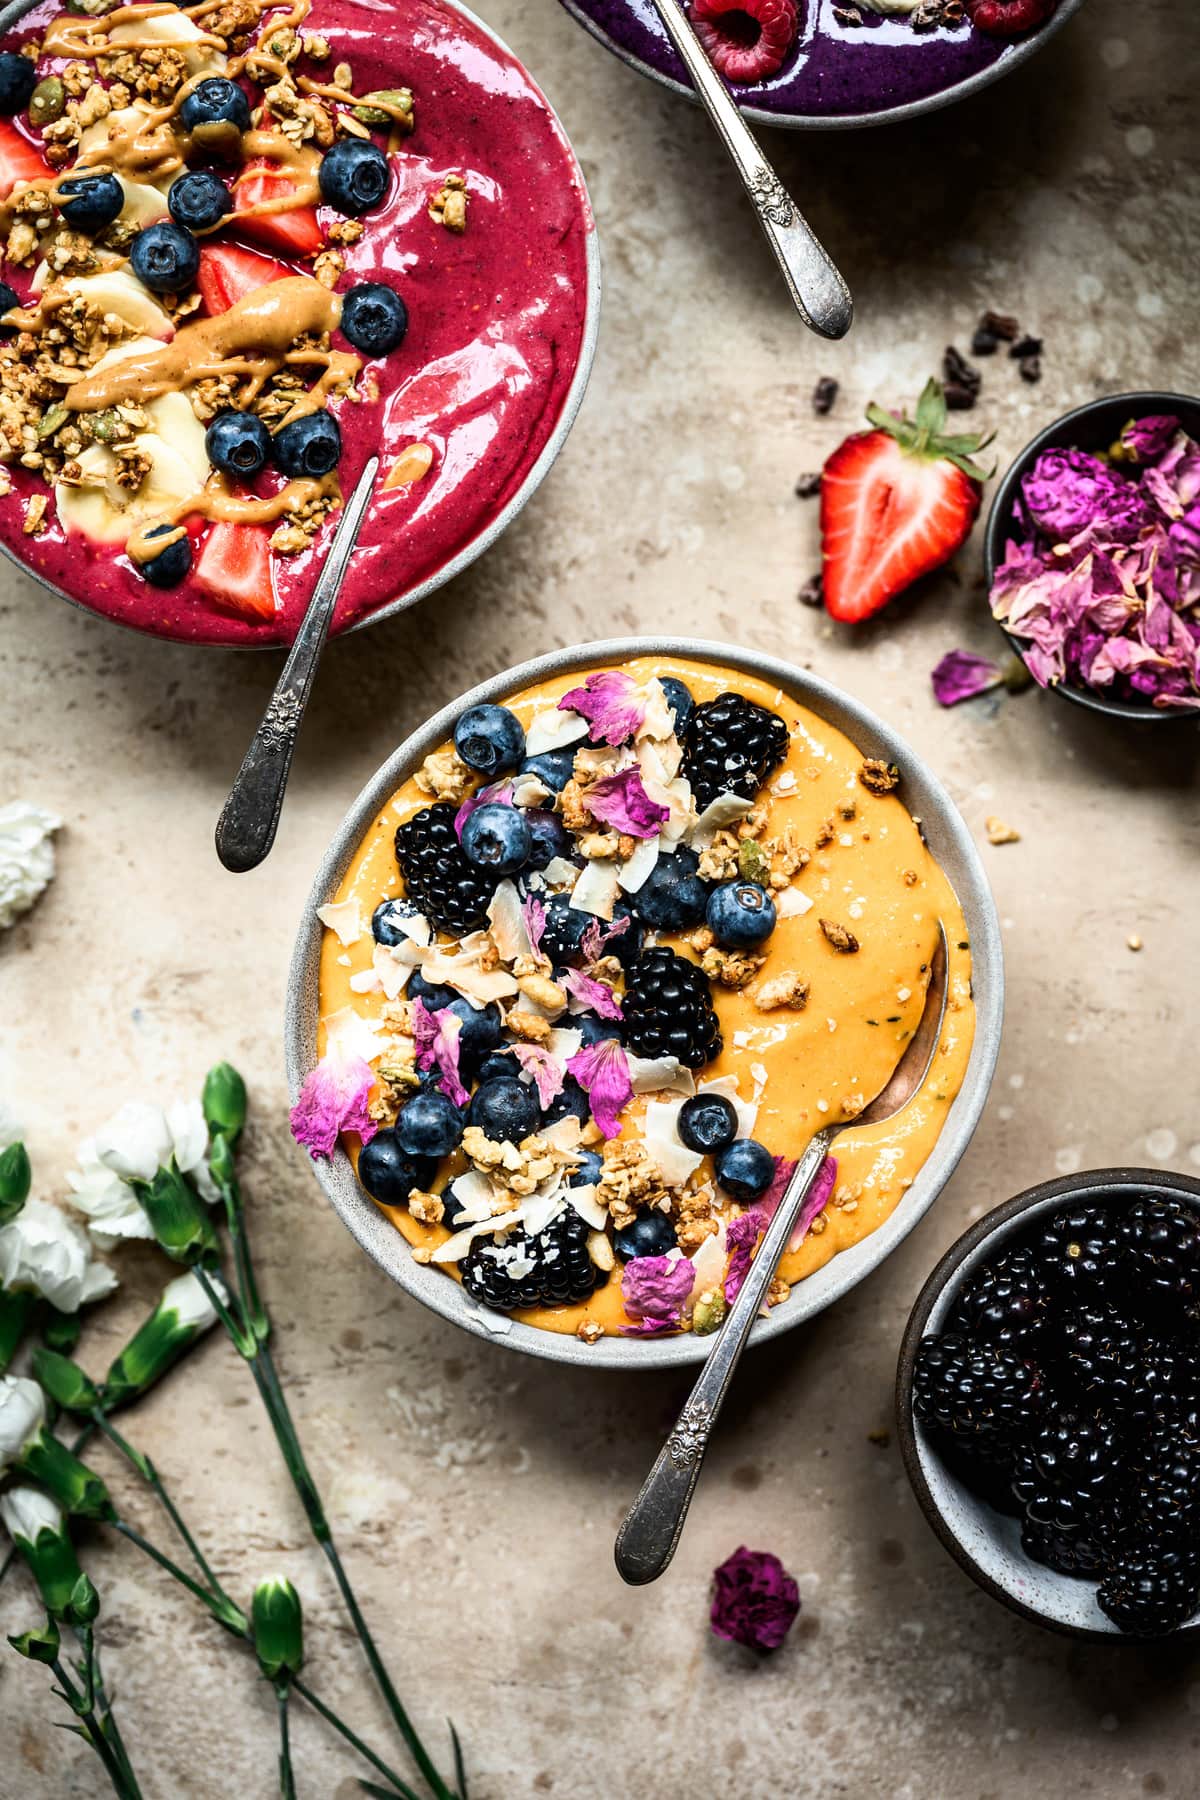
(984, 392), (1200, 724)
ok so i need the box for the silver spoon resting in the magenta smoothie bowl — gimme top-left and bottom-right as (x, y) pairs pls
(216, 455), (380, 875)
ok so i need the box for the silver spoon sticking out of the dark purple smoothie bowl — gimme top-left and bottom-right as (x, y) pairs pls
(655, 0), (855, 338)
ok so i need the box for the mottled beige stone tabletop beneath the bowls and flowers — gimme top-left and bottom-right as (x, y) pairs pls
(0, 0), (1200, 1800)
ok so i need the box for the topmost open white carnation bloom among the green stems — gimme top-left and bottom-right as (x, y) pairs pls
(67, 1100), (219, 1249)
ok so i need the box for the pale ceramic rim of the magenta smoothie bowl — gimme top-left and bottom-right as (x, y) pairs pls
(0, 0), (601, 652)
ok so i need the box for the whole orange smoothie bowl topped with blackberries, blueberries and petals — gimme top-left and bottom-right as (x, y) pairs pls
(290, 641), (1002, 1363)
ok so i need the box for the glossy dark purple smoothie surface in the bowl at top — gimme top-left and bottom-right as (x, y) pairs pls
(563, 0), (1050, 119)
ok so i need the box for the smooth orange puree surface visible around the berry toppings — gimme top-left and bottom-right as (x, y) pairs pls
(318, 657), (975, 1334)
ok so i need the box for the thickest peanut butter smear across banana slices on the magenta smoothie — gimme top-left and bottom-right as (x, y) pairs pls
(63, 275), (347, 412)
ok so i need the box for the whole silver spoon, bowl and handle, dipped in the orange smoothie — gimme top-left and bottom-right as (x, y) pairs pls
(615, 923), (946, 1588)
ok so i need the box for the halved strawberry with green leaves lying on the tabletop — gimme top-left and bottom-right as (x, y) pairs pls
(820, 382), (991, 623)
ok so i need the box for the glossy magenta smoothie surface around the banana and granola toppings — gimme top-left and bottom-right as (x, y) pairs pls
(0, 0), (592, 644)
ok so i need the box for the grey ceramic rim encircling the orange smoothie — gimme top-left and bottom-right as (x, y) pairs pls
(284, 637), (1004, 1370)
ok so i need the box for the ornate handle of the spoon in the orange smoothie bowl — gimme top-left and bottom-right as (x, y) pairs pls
(615, 1129), (833, 1586)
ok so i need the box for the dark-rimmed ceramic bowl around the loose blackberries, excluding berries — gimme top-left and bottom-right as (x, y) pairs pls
(896, 1168), (1200, 1643)
